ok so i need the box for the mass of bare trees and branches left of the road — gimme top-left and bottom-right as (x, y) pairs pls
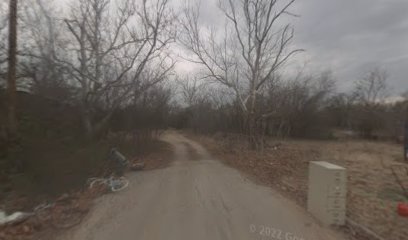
(0, 0), (176, 142)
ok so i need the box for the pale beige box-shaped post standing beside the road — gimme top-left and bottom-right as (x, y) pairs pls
(307, 162), (347, 226)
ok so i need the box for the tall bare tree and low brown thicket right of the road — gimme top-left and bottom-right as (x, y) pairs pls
(174, 0), (406, 150)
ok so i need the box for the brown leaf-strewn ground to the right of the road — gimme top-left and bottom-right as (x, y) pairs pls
(189, 134), (408, 240)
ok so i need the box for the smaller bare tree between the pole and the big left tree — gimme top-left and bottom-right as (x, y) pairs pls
(19, 0), (72, 102)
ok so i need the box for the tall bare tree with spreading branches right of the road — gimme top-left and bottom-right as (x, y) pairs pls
(181, 0), (302, 148)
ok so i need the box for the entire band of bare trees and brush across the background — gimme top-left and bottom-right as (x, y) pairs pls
(0, 0), (407, 152)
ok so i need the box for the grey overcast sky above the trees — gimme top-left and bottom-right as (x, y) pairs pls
(57, 0), (408, 95)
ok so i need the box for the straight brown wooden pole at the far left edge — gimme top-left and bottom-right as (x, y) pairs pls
(7, 0), (17, 141)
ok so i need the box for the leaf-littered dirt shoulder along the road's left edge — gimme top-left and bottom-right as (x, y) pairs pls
(0, 138), (172, 240)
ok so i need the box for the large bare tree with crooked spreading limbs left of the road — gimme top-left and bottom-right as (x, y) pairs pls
(58, 0), (175, 139)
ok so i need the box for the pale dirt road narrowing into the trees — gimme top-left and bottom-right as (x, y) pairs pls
(61, 133), (343, 240)
